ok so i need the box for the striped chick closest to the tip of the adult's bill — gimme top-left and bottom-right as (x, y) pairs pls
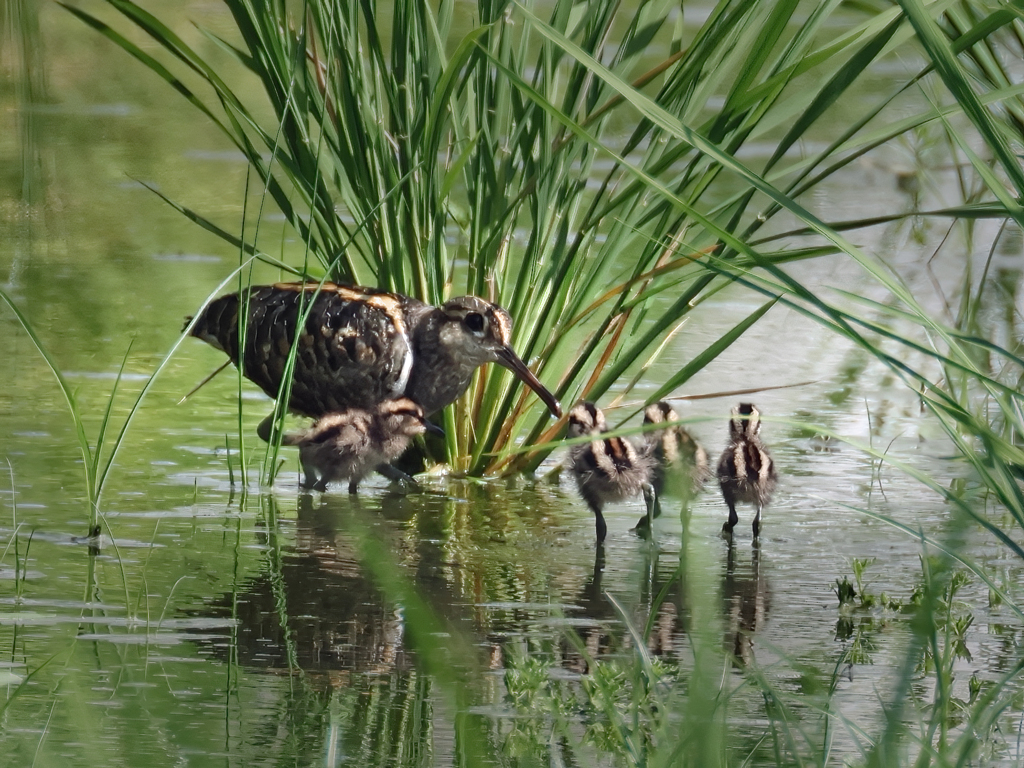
(568, 401), (653, 544)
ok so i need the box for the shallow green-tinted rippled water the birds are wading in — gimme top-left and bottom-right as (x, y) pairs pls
(0, 3), (1024, 766)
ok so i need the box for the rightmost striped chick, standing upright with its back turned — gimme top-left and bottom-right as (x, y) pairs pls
(718, 402), (777, 538)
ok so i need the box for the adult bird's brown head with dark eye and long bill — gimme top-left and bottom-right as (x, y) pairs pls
(440, 296), (562, 416)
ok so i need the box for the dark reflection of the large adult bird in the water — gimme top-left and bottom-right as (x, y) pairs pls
(186, 495), (434, 677)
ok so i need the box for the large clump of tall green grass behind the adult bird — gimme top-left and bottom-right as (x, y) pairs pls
(70, 0), (1005, 473)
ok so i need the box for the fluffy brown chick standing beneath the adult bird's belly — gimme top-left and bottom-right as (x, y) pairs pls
(282, 397), (441, 494)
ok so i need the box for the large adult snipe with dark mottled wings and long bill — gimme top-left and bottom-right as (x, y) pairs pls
(191, 283), (561, 438)
